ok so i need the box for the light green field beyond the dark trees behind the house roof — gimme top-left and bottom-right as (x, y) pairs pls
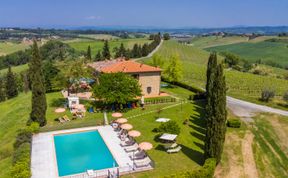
(67, 38), (151, 56)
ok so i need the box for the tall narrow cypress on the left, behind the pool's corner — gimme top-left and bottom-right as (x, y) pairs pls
(29, 41), (47, 127)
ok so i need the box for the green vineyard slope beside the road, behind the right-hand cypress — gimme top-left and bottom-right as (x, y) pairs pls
(144, 40), (288, 109)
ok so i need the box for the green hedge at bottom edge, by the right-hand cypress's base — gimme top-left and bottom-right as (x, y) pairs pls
(165, 158), (216, 178)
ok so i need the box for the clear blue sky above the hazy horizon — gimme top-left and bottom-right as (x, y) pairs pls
(0, 0), (288, 27)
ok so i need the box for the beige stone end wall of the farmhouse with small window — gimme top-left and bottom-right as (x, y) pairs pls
(138, 72), (161, 96)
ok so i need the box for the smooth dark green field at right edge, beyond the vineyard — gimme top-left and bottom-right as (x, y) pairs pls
(207, 41), (288, 67)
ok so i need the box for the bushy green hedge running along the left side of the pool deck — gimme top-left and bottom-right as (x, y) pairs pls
(10, 123), (39, 178)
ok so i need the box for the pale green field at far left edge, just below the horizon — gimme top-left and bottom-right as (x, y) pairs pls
(0, 41), (29, 56)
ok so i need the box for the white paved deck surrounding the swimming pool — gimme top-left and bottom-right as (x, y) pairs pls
(31, 126), (151, 178)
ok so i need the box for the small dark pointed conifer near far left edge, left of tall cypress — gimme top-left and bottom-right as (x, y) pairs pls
(6, 66), (18, 99)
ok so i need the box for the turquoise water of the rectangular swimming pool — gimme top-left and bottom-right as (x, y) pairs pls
(54, 131), (118, 176)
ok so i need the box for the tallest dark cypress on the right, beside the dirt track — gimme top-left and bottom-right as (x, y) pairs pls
(204, 53), (227, 163)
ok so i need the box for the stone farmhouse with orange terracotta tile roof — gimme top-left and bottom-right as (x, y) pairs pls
(88, 58), (161, 97)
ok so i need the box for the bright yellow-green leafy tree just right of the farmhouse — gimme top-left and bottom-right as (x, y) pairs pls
(164, 54), (183, 82)
